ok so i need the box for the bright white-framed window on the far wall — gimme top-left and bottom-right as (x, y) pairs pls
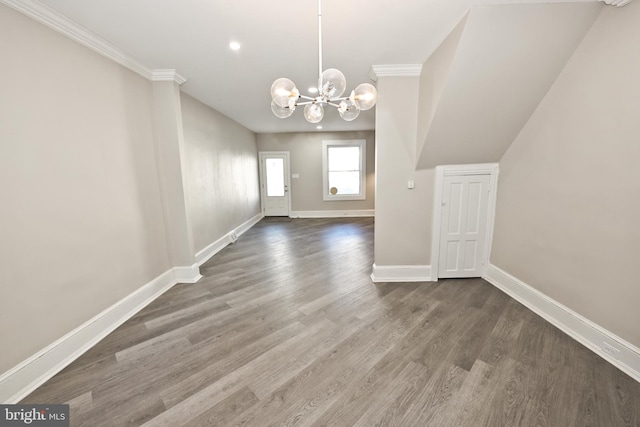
(322, 139), (367, 200)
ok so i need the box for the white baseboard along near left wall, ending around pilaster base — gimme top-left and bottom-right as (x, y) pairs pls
(0, 264), (201, 403)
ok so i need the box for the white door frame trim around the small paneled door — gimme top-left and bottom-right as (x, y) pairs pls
(431, 163), (499, 282)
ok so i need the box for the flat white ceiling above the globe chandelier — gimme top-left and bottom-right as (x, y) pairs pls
(33, 0), (596, 133)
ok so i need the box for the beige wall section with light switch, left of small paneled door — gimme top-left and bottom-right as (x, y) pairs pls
(374, 76), (435, 267)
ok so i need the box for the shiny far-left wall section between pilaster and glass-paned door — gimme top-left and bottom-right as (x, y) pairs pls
(182, 93), (260, 252)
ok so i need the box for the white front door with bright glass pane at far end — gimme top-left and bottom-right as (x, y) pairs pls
(260, 151), (290, 216)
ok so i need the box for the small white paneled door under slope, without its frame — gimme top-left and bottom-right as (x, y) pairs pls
(438, 175), (491, 278)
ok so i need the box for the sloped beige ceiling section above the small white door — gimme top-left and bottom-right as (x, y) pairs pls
(416, 3), (602, 169)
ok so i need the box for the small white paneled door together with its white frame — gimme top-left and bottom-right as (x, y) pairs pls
(431, 164), (498, 278)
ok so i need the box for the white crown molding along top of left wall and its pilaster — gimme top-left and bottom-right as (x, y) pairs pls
(0, 0), (186, 84)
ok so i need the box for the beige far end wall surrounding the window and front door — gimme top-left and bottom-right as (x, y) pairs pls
(258, 131), (375, 211)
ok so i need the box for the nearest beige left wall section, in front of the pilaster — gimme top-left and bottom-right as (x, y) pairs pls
(0, 5), (171, 372)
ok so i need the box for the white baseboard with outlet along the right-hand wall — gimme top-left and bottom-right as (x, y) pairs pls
(484, 264), (640, 382)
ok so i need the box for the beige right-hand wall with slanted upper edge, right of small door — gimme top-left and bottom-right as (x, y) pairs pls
(491, 1), (640, 346)
